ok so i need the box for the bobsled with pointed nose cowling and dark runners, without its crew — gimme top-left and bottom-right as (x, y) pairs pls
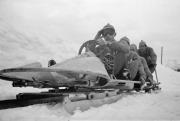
(0, 41), (160, 112)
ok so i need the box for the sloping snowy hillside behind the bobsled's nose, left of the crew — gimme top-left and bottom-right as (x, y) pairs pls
(0, 17), (78, 68)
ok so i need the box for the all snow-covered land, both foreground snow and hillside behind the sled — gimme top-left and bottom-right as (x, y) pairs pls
(0, 21), (180, 121)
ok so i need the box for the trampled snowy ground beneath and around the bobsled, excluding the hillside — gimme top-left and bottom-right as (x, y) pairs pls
(0, 65), (180, 121)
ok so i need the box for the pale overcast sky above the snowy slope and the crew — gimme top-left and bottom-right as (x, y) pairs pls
(0, 0), (180, 63)
